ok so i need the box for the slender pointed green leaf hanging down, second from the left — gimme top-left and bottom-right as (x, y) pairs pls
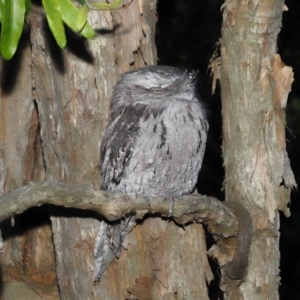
(42, 0), (67, 48)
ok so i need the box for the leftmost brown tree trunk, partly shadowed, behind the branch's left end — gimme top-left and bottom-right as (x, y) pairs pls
(0, 30), (58, 300)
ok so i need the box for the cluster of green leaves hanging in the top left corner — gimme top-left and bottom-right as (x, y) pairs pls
(0, 0), (122, 60)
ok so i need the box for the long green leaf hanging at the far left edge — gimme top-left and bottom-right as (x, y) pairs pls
(0, 0), (25, 60)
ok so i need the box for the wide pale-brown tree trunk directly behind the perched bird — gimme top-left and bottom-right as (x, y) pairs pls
(31, 0), (212, 300)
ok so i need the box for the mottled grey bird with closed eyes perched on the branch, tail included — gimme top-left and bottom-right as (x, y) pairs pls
(94, 66), (208, 282)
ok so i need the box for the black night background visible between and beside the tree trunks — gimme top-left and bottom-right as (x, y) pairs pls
(156, 0), (300, 300)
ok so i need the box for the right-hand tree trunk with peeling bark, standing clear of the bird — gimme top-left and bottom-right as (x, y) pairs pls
(221, 0), (295, 299)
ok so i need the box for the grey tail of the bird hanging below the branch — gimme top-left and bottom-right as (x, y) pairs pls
(94, 216), (136, 284)
